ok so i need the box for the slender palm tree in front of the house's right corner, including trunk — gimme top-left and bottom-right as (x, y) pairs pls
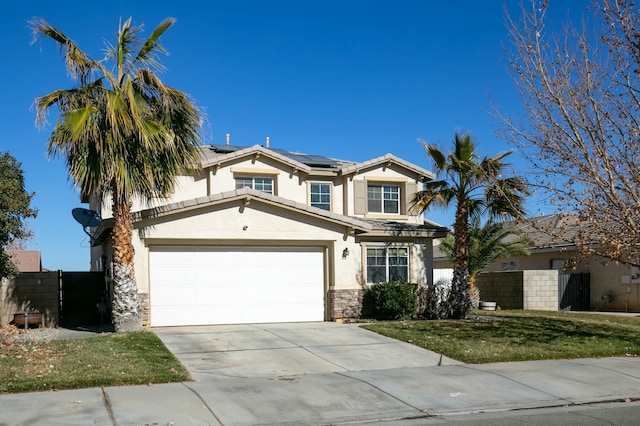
(413, 132), (528, 318)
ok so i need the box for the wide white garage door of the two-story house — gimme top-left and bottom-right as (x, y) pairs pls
(149, 247), (324, 326)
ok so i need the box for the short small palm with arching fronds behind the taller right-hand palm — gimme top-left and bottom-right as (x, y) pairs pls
(440, 216), (531, 309)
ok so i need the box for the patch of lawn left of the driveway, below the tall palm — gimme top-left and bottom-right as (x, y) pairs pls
(0, 331), (190, 393)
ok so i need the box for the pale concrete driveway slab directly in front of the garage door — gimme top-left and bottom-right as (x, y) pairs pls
(153, 322), (460, 381)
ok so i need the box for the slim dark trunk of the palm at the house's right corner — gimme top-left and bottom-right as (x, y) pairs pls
(449, 199), (471, 319)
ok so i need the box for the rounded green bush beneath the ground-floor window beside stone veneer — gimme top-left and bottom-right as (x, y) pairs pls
(362, 282), (418, 320)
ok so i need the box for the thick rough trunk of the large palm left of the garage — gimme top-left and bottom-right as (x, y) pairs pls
(111, 188), (142, 332)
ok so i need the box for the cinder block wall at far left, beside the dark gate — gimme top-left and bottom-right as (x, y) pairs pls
(0, 272), (59, 327)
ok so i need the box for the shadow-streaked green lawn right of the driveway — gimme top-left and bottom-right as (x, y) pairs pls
(361, 311), (640, 364)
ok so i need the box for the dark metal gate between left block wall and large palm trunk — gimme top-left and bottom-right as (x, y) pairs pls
(60, 272), (111, 328)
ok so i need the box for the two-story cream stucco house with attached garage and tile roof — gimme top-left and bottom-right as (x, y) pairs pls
(90, 141), (447, 326)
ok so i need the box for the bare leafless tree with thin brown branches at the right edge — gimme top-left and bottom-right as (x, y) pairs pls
(498, 0), (640, 265)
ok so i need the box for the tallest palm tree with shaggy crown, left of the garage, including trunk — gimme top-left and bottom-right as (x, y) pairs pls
(30, 18), (203, 331)
